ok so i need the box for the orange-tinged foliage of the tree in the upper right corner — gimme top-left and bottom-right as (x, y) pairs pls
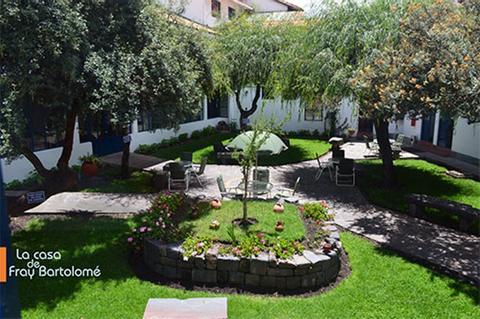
(352, 0), (480, 122)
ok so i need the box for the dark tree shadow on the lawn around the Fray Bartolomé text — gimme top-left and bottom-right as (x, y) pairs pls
(12, 217), (135, 309)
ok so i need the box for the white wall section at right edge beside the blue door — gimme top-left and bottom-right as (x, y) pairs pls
(452, 118), (480, 159)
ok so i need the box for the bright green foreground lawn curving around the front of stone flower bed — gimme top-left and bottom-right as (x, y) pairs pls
(13, 218), (480, 319)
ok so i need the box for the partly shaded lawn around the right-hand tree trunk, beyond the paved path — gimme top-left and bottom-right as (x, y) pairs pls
(357, 160), (480, 233)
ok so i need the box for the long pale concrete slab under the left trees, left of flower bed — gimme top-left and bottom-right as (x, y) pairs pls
(25, 192), (154, 214)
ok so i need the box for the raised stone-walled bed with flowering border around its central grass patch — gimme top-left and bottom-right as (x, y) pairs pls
(128, 194), (341, 292)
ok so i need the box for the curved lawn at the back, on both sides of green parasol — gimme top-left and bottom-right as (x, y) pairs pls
(135, 134), (330, 166)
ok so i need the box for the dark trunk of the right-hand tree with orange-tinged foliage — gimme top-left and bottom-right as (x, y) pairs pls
(375, 120), (396, 187)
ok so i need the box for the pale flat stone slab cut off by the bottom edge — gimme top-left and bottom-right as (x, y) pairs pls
(143, 298), (228, 319)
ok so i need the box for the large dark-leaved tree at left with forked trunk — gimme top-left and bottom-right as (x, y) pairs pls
(0, 0), (208, 191)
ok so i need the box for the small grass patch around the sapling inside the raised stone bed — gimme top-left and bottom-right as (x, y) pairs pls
(184, 201), (305, 242)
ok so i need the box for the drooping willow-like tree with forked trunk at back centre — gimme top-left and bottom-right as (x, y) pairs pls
(211, 15), (285, 126)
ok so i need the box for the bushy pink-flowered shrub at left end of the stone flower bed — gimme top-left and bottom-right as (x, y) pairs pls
(128, 193), (186, 251)
